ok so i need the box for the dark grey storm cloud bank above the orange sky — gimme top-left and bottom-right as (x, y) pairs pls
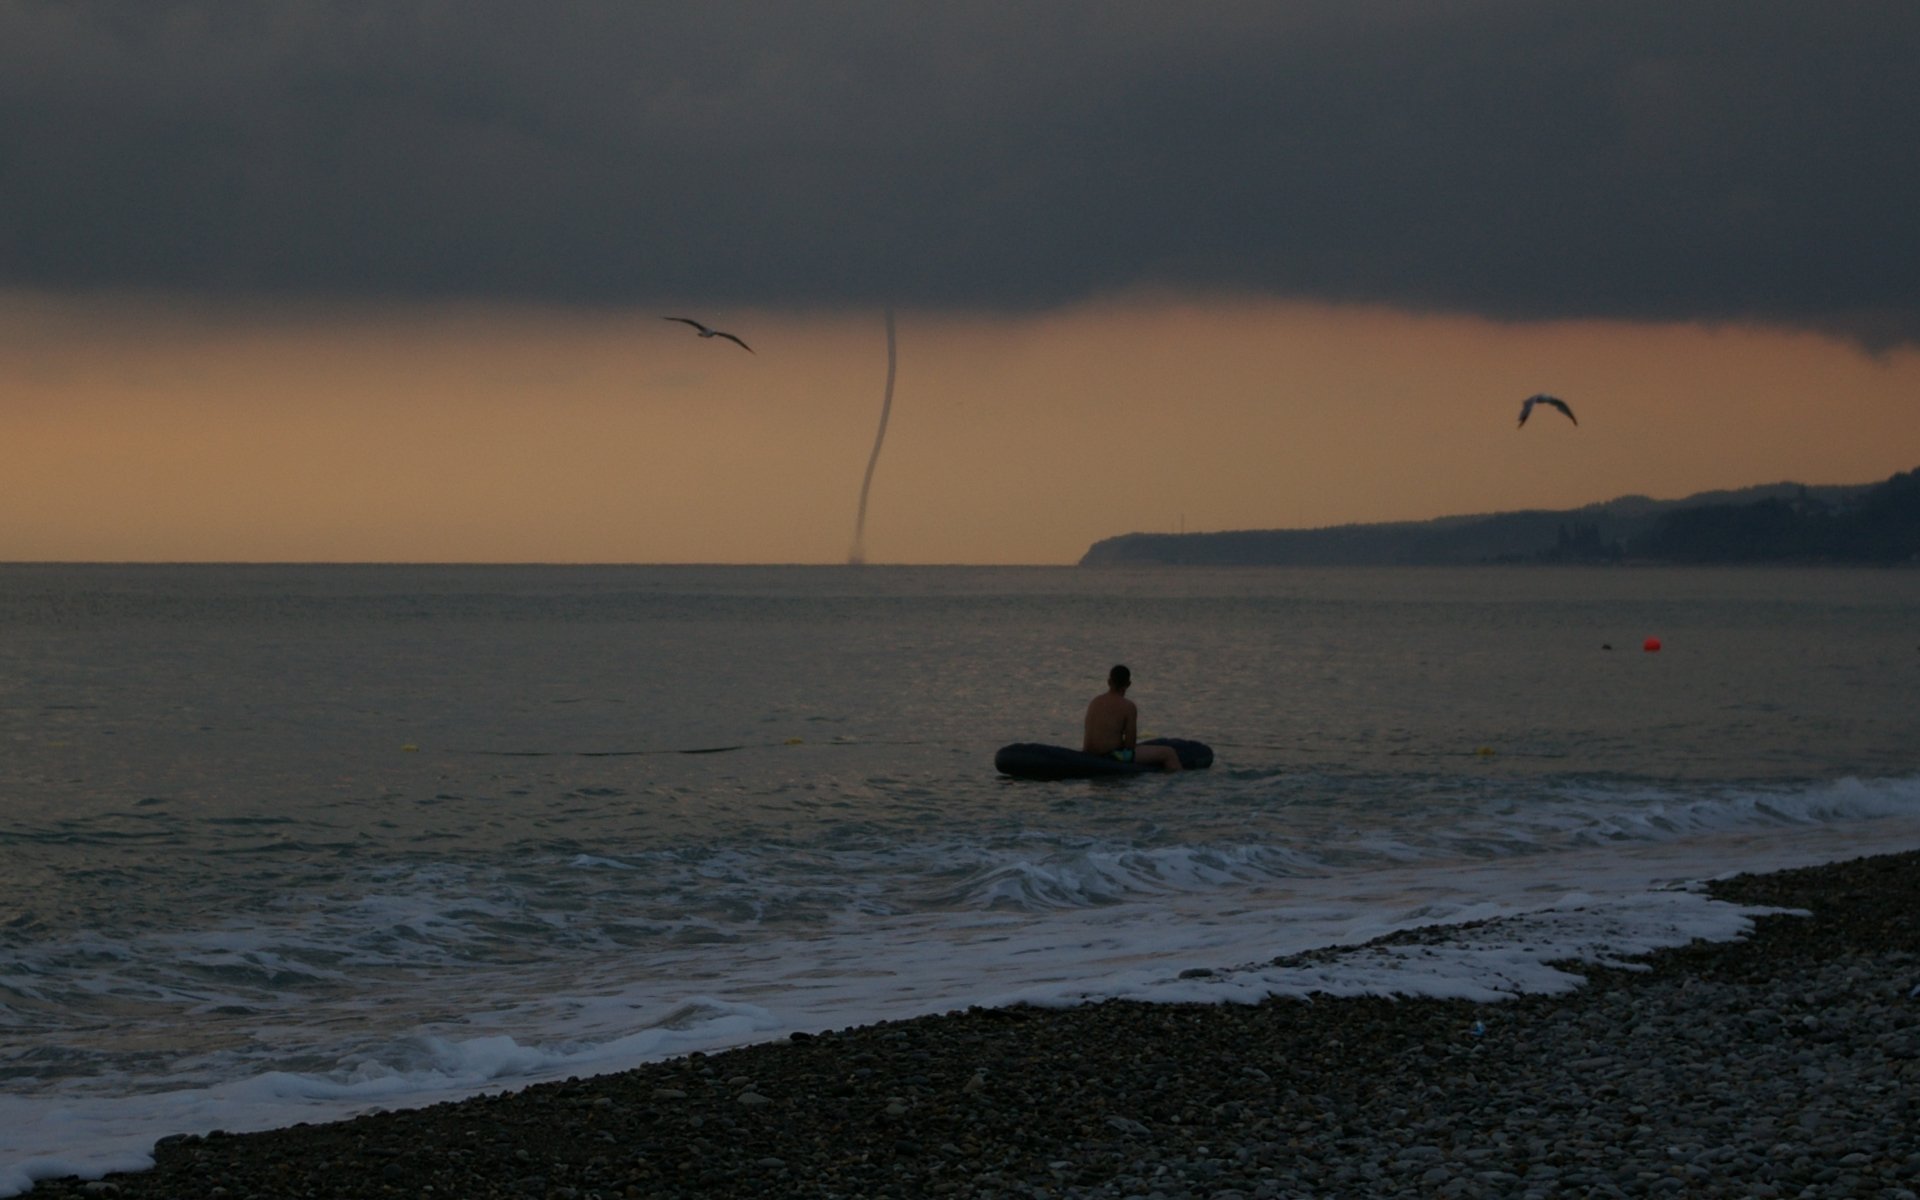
(0, 0), (1920, 342)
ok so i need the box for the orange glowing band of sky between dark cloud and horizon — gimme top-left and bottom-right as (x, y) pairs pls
(0, 294), (1920, 564)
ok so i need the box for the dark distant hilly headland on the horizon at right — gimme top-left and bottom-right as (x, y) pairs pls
(1081, 470), (1920, 566)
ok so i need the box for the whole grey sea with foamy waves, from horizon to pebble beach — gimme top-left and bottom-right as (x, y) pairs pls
(0, 564), (1920, 1194)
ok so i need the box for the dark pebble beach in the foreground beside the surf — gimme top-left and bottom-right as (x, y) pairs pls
(25, 852), (1920, 1200)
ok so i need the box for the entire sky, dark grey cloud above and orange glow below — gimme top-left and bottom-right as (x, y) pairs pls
(0, 0), (1920, 564)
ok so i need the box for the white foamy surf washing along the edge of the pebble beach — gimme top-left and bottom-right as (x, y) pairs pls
(11, 810), (1920, 1194)
